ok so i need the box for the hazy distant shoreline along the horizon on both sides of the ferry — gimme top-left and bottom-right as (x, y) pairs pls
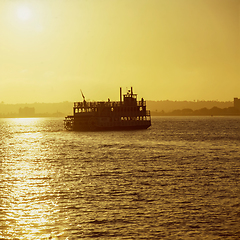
(0, 100), (240, 118)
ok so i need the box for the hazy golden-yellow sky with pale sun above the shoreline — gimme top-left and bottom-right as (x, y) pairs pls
(0, 0), (240, 103)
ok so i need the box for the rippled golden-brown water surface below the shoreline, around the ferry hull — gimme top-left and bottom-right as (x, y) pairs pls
(0, 117), (240, 239)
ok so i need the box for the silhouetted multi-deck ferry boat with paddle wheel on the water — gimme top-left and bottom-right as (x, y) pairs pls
(64, 87), (151, 131)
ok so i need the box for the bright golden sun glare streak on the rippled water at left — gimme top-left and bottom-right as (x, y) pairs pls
(0, 119), (62, 239)
